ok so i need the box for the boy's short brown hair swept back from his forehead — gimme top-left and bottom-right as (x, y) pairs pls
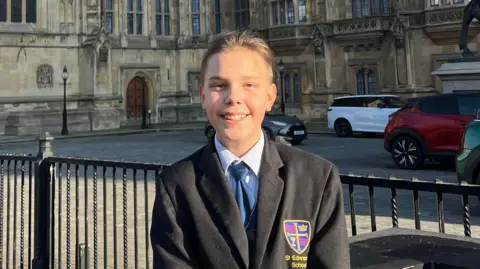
(200, 30), (276, 86)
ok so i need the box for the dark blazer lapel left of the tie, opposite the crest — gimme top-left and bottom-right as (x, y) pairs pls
(199, 139), (250, 268)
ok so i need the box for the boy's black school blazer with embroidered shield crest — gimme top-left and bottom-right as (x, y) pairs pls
(150, 135), (350, 269)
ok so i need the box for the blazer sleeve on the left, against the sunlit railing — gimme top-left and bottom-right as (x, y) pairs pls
(150, 171), (197, 269)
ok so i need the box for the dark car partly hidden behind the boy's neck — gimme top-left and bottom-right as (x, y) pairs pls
(205, 113), (307, 145)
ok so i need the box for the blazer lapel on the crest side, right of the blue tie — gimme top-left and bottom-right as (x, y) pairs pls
(253, 139), (284, 268)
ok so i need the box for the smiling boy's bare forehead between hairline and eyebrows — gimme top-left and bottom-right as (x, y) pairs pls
(205, 48), (271, 79)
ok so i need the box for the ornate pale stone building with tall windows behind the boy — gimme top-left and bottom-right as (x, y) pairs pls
(0, 0), (479, 135)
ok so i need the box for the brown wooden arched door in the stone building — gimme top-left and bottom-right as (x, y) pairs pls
(125, 76), (150, 128)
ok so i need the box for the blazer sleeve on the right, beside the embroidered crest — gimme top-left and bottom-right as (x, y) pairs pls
(307, 165), (350, 269)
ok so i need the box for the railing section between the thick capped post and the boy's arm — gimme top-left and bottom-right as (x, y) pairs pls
(48, 157), (163, 268)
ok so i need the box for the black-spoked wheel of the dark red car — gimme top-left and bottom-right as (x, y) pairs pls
(392, 136), (425, 169)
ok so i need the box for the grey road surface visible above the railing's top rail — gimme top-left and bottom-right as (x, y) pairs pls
(0, 132), (456, 182)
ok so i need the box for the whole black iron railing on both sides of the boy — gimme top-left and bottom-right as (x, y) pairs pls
(0, 132), (480, 269)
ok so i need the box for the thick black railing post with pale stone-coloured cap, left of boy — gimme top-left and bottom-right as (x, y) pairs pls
(32, 133), (54, 269)
